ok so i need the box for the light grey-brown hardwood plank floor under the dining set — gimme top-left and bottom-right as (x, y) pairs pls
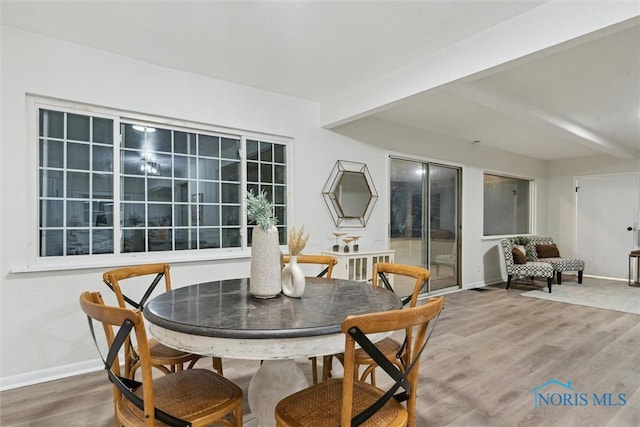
(0, 277), (640, 427)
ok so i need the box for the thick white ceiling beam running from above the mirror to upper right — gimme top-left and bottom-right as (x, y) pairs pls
(320, 0), (640, 129)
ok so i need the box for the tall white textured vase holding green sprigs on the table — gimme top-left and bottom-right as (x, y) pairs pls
(249, 226), (282, 298)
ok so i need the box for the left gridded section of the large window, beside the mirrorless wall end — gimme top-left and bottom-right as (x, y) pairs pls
(38, 110), (114, 256)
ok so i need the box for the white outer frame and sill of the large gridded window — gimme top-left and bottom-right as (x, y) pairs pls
(26, 95), (293, 271)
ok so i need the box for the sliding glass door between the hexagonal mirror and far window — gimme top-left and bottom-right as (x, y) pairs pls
(390, 158), (460, 295)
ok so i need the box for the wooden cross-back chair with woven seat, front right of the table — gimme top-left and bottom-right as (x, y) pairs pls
(275, 297), (444, 427)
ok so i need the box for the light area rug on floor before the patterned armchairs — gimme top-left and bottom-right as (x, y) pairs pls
(521, 281), (640, 314)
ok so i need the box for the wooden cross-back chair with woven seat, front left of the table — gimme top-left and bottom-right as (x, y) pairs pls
(80, 292), (242, 427)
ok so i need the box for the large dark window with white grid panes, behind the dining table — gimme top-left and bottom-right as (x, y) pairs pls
(37, 106), (287, 257)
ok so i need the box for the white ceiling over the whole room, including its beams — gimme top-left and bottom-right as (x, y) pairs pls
(1, 0), (640, 159)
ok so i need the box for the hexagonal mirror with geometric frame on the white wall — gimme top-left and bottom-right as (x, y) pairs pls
(322, 160), (378, 227)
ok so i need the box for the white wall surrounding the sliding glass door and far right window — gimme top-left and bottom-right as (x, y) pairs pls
(338, 118), (547, 288)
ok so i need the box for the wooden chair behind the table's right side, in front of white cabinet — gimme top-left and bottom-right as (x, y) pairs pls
(322, 262), (431, 385)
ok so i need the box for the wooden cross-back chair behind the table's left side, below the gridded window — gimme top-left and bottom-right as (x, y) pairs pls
(102, 264), (222, 378)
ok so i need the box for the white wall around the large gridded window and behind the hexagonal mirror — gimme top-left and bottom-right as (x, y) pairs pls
(0, 27), (386, 387)
